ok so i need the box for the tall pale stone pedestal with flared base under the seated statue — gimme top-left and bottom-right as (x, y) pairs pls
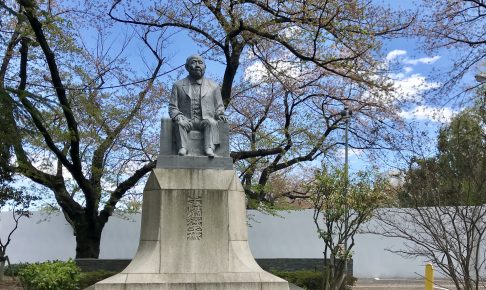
(94, 168), (289, 290)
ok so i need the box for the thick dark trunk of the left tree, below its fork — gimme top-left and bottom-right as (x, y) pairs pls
(74, 217), (104, 259)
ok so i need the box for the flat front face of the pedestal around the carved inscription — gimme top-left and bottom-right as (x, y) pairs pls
(160, 190), (228, 273)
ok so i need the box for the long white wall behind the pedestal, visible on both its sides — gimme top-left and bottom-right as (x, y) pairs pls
(0, 210), (425, 278)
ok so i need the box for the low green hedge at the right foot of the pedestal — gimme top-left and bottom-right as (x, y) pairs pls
(271, 270), (357, 290)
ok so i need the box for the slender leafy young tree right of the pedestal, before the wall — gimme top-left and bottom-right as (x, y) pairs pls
(309, 168), (391, 289)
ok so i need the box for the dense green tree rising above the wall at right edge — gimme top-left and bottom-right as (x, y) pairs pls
(399, 100), (486, 206)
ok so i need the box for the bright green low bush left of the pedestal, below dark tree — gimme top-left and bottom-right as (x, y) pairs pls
(18, 259), (81, 290)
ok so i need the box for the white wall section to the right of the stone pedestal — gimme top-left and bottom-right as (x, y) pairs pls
(249, 210), (426, 278)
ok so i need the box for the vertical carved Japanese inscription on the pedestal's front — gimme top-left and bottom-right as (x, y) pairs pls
(186, 192), (202, 240)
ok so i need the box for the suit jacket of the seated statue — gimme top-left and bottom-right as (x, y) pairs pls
(169, 77), (224, 144)
